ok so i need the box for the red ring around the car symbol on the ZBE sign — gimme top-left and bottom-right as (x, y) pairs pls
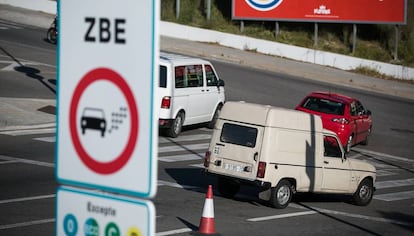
(69, 68), (139, 174)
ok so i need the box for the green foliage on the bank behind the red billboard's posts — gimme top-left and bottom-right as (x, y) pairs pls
(161, 0), (414, 67)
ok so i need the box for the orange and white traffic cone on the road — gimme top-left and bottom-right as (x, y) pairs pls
(198, 185), (216, 234)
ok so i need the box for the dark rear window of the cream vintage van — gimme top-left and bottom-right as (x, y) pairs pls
(220, 123), (257, 148)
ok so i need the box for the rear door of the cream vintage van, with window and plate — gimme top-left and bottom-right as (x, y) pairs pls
(209, 120), (264, 180)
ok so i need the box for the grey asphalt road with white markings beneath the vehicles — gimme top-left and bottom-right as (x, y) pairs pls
(0, 10), (414, 235)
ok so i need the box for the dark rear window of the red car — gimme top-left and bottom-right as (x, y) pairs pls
(302, 97), (345, 115)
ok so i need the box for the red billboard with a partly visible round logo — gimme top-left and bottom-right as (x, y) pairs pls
(232, 0), (407, 24)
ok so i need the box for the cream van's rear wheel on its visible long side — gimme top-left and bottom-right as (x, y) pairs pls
(269, 179), (293, 209)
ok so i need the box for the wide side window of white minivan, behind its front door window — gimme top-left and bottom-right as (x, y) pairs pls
(175, 65), (203, 88)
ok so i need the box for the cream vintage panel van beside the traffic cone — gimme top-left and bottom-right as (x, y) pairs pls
(204, 102), (376, 208)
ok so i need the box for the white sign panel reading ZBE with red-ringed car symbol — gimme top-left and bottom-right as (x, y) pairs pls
(57, 0), (159, 197)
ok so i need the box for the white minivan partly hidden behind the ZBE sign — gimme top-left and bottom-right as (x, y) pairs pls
(158, 52), (225, 137)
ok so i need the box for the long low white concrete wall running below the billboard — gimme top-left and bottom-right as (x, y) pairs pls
(0, 0), (414, 80)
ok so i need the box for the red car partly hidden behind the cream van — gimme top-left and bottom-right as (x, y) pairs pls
(296, 92), (372, 152)
